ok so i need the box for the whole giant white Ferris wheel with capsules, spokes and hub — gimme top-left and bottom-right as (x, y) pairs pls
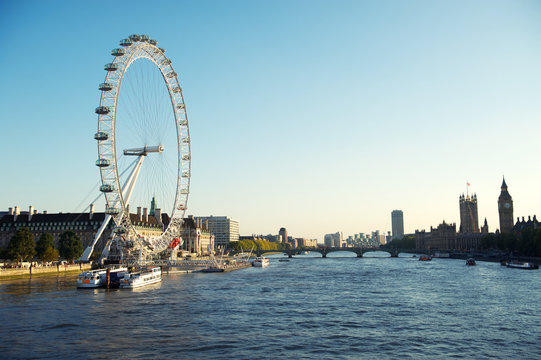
(90, 35), (191, 257)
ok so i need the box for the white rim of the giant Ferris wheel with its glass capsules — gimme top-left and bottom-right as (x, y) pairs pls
(95, 35), (191, 253)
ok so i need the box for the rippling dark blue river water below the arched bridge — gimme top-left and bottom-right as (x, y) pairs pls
(0, 253), (541, 359)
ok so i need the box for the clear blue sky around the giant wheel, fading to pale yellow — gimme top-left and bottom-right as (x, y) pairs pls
(0, 0), (541, 239)
